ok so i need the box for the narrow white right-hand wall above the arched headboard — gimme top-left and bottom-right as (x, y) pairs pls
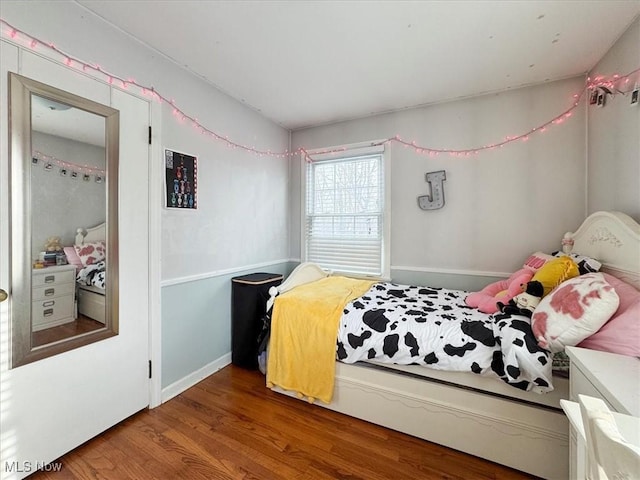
(587, 18), (640, 222)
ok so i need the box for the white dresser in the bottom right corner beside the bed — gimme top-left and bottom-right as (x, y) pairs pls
(563, 347), (640, 480)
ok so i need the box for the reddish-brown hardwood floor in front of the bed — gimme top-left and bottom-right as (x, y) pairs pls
(30, 366), (533, 480)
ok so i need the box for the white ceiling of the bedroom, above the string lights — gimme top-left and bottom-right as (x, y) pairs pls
(77, 0), (640, 130)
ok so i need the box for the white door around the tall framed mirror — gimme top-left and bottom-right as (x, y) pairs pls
(0, 41), (150, 479)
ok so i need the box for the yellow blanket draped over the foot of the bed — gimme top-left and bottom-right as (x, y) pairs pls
(267, 277), (375, 403)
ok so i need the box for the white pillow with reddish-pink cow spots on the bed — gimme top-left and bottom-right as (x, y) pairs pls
(531, 273), (620, 352)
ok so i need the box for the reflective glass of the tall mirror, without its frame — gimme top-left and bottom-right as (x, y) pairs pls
(31, 94), (107, 347)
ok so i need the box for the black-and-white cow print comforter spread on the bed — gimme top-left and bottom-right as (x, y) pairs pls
(337, 282), (553, 393)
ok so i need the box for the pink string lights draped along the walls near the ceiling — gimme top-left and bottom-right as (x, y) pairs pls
(0, 19), (640, 162)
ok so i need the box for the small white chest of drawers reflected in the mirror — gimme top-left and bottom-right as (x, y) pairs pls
(31, 265), (76, 332)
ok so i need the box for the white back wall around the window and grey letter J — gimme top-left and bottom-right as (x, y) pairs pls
(291, 77), (586, 278)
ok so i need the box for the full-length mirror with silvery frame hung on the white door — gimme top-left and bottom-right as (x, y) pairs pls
(9, 73), (119, 367)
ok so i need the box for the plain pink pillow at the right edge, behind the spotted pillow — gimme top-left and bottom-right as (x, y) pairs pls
(578, 273), (640, 357)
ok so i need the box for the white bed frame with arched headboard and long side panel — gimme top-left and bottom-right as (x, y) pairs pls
(271, 212), (640, 479)
